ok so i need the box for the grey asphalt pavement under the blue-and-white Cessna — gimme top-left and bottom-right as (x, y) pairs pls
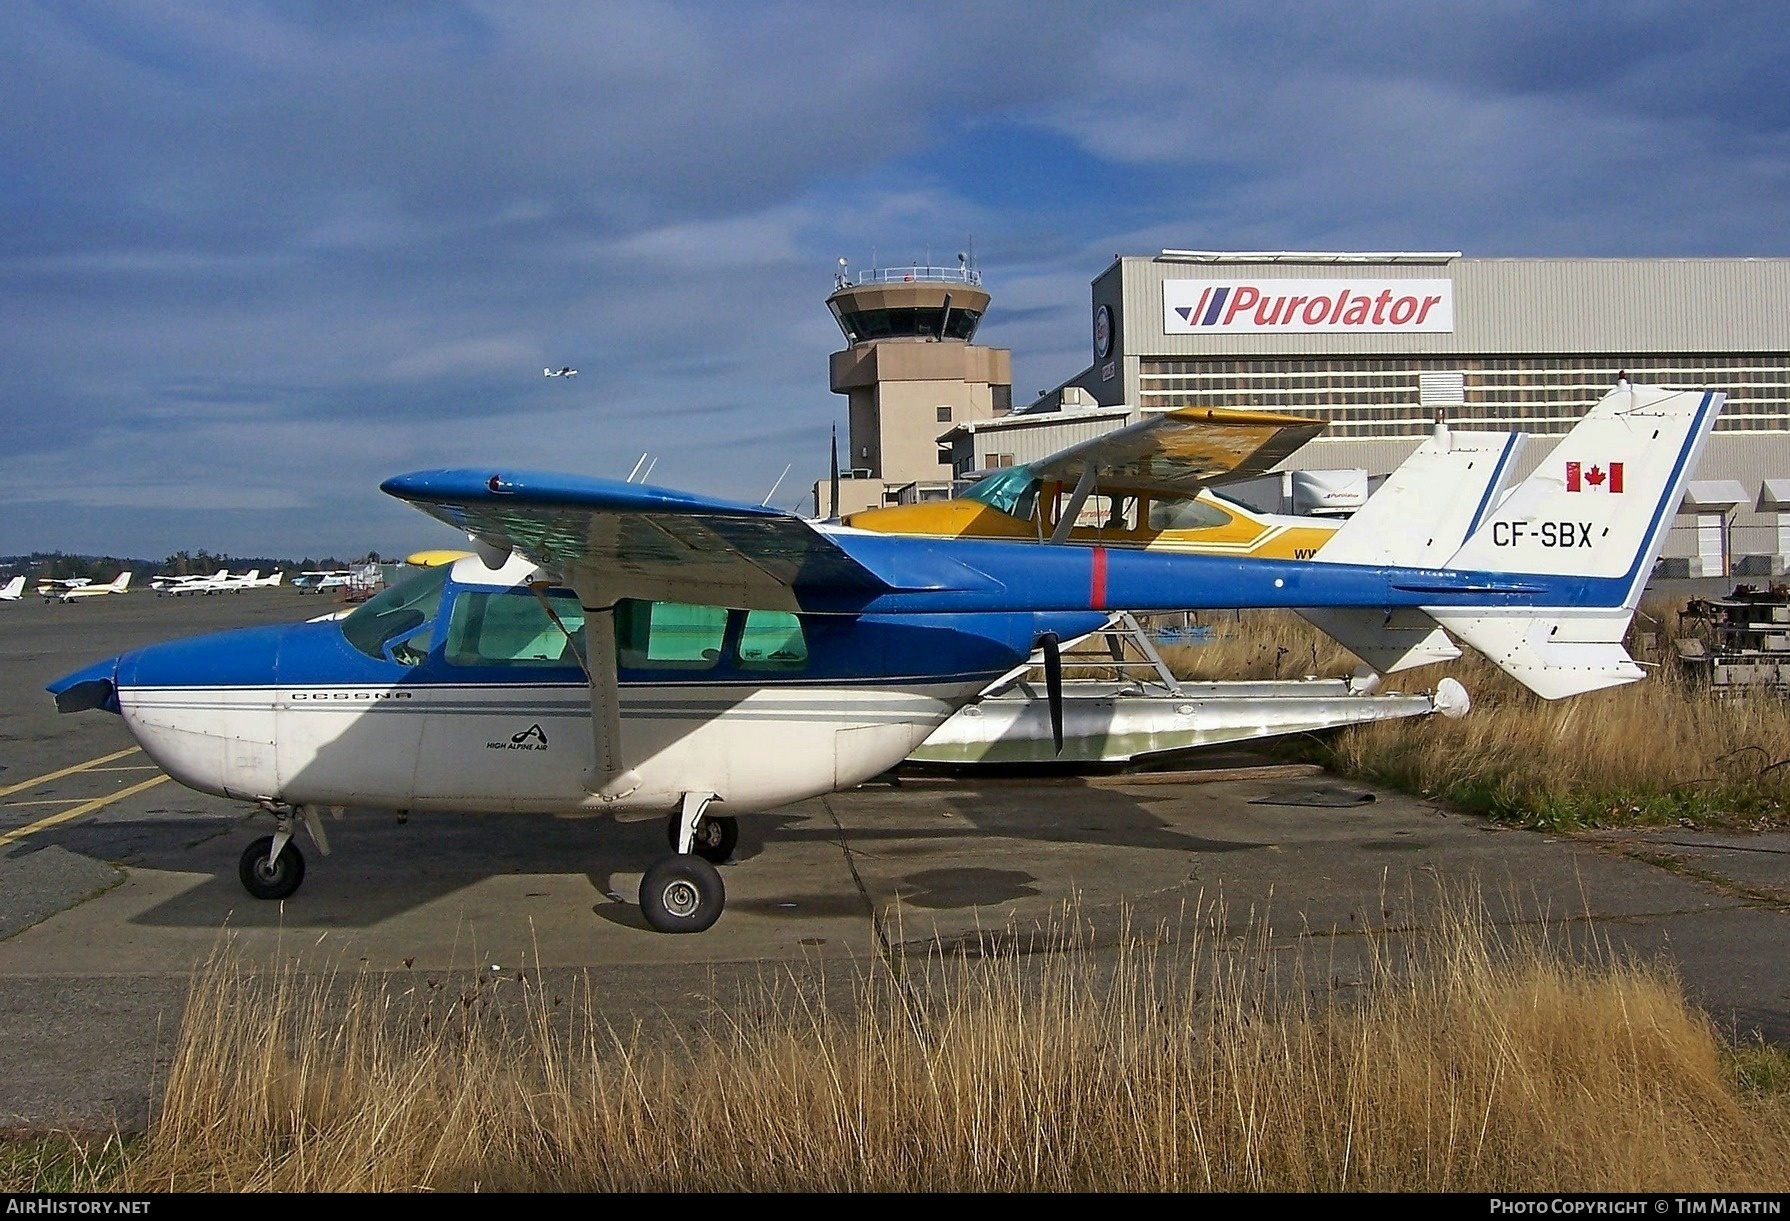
(0, 589), (1790, 1128)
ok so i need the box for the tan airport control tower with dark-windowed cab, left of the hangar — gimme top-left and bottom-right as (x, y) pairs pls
(814, 254), (1013, 517)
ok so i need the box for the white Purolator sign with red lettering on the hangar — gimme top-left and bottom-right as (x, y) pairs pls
(1162, 279), (1453, 335)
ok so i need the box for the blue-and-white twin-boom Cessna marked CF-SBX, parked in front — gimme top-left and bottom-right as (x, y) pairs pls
(50, 385), (1722, 933)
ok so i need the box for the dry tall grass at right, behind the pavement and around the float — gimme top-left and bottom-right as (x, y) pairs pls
(1165, 607), (1790, 825)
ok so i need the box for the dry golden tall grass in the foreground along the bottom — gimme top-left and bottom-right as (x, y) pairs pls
(101, 888), (1790, 1191)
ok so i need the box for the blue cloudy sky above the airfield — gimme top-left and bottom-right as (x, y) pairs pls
(0, 0), (1790, 557)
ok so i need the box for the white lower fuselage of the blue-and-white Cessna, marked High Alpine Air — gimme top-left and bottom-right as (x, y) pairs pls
(118, 680), (985, 813)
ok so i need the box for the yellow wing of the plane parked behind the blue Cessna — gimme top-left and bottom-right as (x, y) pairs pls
(1031, 406), (1325, 494)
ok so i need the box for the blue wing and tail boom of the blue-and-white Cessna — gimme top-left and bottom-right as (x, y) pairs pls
(381, 469), (1517, 614)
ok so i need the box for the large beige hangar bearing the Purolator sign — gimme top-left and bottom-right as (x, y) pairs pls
(1045, 251), (1790, 576)
